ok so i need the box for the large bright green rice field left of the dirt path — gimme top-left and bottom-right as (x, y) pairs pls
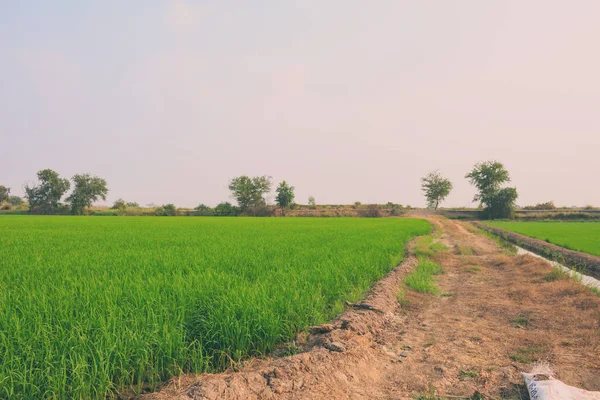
(0, 216), (432, 399)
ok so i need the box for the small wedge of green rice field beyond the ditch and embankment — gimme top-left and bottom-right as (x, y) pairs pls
(489, 222), (600, 256)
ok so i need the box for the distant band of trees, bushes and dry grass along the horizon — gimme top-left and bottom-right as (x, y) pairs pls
(0, 161), (600, 219)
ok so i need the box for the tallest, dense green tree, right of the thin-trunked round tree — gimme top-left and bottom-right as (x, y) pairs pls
(465, 161), (518, 219)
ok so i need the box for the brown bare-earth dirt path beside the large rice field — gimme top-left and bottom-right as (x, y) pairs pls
(144, 216), (600, 400)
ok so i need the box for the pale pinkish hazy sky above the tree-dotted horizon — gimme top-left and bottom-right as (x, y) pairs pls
(0, 0), (600, 207)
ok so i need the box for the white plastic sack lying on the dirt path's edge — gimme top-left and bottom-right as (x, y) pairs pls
(523, 373), (600, 400)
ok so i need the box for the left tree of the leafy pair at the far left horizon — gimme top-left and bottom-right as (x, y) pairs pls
(25, 169), (71, 214)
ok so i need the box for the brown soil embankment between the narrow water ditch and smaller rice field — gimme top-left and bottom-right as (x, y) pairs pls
(473, 222), (600, 279)
